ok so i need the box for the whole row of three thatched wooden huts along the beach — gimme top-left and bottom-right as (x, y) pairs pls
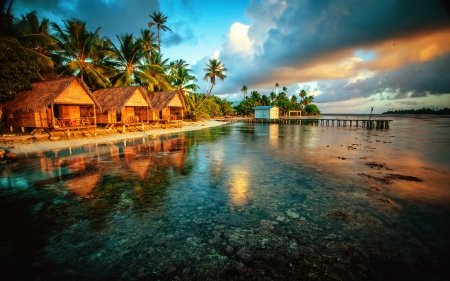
(5, 76), (185, 132)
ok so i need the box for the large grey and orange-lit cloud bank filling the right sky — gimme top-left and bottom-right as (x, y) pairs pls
(201, 0), (450, 109)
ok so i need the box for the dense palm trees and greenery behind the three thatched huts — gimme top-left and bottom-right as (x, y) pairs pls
(0, 0), (233, 119)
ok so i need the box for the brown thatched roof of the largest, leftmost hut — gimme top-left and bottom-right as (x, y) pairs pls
(5, 76), (97, 111)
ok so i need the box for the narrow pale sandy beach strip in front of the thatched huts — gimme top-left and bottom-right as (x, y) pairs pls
(0, 120), (229, 157)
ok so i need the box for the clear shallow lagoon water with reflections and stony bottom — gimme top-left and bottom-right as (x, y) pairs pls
(0, 116), (450, 280)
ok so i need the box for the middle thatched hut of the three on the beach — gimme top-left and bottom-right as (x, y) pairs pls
(94, 86), (152, 124)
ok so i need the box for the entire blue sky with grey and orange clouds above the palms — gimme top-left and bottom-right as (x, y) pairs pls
(13, 0), (450, 114)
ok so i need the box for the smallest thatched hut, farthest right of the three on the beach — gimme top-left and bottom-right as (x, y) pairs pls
(148, 91), (186, 120)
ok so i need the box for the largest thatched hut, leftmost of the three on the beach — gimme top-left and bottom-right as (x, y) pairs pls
(5, 76), (97, 131)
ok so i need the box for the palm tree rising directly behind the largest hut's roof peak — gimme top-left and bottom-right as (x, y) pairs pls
(51, 19), (111, 88)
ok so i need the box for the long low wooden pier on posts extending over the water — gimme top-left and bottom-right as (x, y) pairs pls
(241, 118), (393, 129)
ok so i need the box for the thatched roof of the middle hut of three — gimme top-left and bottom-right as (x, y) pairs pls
(94, 86), (152, 112)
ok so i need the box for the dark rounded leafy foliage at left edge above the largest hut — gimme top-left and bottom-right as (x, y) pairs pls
(0, 38), (39, 103)
